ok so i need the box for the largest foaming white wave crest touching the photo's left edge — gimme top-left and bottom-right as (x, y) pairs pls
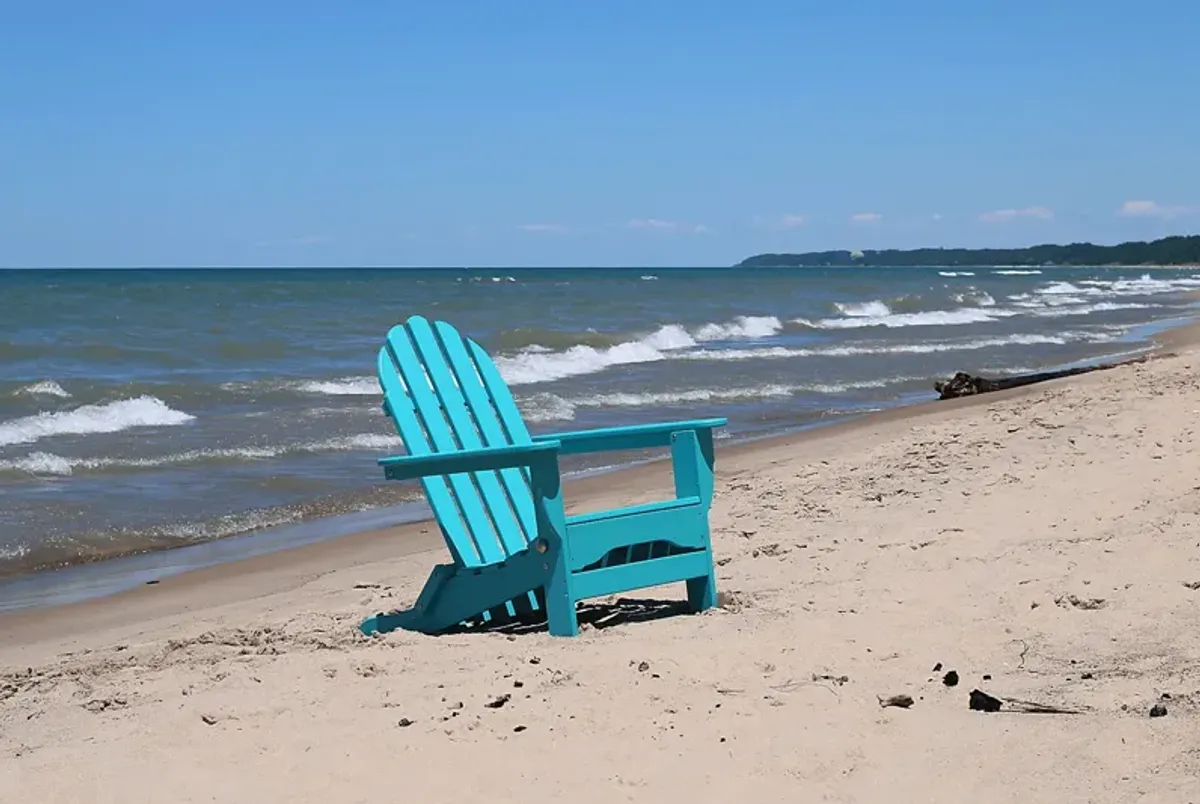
(0, 396), (196, 446)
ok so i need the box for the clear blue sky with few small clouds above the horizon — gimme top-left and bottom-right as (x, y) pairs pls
(0, 0), (1200, 266)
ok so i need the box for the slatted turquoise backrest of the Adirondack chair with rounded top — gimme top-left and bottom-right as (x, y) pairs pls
(378, 316), (536, 566)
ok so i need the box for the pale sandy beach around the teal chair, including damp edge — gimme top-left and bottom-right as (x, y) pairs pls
(0, 332), (1200, 804)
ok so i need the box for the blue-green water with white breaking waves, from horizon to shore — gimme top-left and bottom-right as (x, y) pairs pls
(0, 268), (1200, 576)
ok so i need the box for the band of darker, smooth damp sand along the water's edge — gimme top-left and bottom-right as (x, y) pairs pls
(0, 322), (1200, 644)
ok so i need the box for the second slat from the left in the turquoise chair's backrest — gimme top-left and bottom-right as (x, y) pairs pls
(385, 317), (503, 566)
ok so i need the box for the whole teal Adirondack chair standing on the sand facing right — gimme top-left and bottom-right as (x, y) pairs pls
(361, 316), (726, 636)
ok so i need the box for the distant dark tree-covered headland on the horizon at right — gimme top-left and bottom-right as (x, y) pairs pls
(734, 235), (1200, 268)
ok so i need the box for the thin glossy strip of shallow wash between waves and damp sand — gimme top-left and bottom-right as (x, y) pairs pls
(0, 319), (1185, 628)
